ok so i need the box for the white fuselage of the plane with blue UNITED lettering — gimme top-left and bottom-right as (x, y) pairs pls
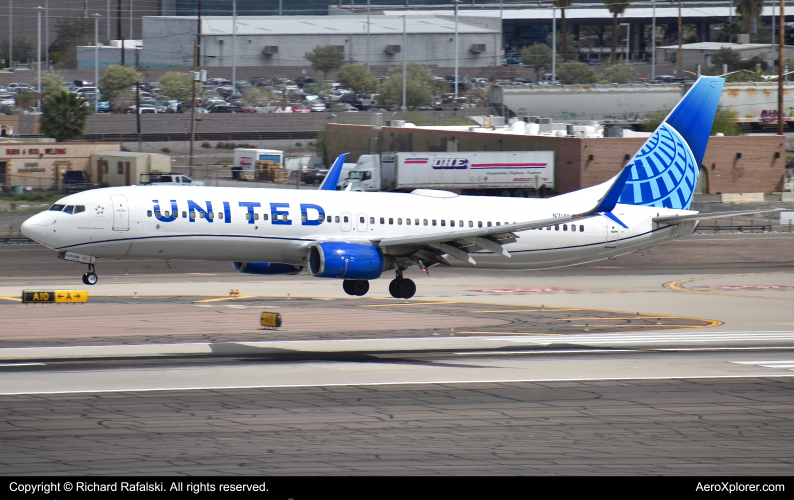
(23, 186), (696, 269)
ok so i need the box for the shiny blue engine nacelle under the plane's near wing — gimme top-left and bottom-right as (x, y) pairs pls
(309, 241), (395, 280)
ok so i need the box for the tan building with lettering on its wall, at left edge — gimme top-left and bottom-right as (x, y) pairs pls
(0, 141), (119, 191)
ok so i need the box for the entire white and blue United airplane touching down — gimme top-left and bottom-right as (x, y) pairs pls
(22, 77), (776, 299)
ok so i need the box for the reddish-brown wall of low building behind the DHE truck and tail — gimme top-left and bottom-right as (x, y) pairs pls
(326, 124), (786, 194)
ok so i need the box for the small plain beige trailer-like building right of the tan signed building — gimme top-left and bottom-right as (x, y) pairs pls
(89, 151), (171, 186)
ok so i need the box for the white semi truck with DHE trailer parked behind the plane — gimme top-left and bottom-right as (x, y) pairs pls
(345, 151), (554, 197)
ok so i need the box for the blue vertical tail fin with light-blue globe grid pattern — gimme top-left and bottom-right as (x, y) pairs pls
(617, 77), (725, 210)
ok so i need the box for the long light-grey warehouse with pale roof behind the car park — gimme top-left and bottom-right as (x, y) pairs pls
(141, 16), (501, 68)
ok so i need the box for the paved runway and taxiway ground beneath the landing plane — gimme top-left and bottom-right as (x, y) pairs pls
(0, 235), (794, 476)
